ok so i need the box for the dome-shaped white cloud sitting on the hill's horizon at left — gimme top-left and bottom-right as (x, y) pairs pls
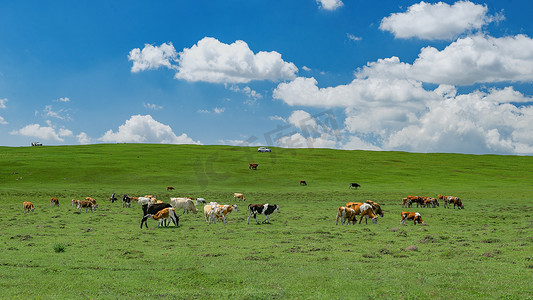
(99, 115), (201, 144)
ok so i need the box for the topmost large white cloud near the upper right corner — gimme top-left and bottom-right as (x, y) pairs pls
(379, 1), (503, 40)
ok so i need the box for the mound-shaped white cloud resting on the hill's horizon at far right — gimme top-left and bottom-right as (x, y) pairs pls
(384, 88), (533, 154)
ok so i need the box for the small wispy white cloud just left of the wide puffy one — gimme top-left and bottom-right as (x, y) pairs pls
(128, 43), (178, 73)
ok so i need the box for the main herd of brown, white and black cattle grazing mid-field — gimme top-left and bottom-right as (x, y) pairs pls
(23, 191), (464, 228)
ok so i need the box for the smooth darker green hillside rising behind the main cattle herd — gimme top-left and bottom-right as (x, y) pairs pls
(0, 144), (533, 197)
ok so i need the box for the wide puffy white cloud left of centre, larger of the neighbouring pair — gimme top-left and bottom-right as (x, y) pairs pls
(175, 37), (298, 83)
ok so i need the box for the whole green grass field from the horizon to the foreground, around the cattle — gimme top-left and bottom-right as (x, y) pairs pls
(0, 144), (533, 299)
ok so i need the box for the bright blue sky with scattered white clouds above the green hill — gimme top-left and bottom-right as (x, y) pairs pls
(0, 0), (533, 155)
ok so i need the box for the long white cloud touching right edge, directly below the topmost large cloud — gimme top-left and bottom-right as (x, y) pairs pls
(355, 35), (533, 85)
